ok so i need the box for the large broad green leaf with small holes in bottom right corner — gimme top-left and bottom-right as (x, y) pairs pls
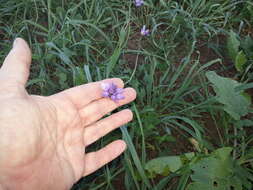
(187, 147), (243, 190)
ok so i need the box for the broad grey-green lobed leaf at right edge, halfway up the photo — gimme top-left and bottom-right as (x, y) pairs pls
(206, 71), (250, 120)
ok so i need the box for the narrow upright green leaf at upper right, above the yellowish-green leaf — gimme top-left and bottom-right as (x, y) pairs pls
(227, 30), (240, 62)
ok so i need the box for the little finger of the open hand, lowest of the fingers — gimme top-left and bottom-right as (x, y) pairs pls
(83, 140), (126, 176)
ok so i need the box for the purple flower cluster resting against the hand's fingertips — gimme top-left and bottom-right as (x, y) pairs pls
(101, 83), (125, 102)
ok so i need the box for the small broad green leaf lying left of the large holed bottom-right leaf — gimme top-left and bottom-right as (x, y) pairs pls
(145, 156), (182, 176)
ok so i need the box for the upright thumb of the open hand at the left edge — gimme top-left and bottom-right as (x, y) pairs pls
(0, 38), (31, 86)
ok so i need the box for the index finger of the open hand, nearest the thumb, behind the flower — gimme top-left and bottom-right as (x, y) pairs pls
(53, 78), (124, 109)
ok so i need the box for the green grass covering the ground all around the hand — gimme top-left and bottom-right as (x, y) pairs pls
(0, 0), (253, 190)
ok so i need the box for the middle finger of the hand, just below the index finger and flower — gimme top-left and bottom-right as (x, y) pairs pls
(79, 88), (136, 126)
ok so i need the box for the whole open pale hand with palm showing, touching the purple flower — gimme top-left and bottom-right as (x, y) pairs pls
(0, 38), (136, 190)
